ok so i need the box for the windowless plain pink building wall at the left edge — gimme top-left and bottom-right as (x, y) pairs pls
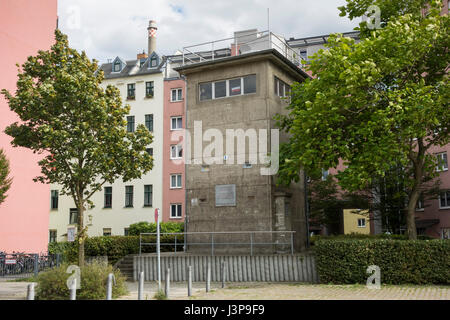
(0, 0), (57, 253)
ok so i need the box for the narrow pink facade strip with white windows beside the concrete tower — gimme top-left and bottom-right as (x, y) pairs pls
(162, 77), (186, 222)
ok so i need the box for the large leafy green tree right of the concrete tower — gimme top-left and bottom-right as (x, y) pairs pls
(278, 1), (450, 239)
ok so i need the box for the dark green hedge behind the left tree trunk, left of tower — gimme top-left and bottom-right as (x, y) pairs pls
(48, 235), (184, 263)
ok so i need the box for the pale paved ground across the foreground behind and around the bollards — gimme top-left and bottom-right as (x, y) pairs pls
(0, 279), (450, 300)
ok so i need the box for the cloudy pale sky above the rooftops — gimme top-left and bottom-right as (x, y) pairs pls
(58, 0), (359, 63)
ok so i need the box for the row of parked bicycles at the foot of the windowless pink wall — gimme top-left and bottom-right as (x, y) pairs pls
(0, 252), (61, 278)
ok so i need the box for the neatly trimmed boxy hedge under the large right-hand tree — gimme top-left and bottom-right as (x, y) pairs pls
(314, 239), (450, 285)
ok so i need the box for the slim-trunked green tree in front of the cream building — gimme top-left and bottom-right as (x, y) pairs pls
(2, 30), (153, 265)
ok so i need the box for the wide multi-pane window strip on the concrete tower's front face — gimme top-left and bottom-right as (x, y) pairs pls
(199, 74), (256, 101)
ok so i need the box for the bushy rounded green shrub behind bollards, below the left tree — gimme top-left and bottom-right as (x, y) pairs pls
(36, 263), (128, 300)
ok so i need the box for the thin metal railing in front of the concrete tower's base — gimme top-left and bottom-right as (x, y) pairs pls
(139, 231), (295, 256)
